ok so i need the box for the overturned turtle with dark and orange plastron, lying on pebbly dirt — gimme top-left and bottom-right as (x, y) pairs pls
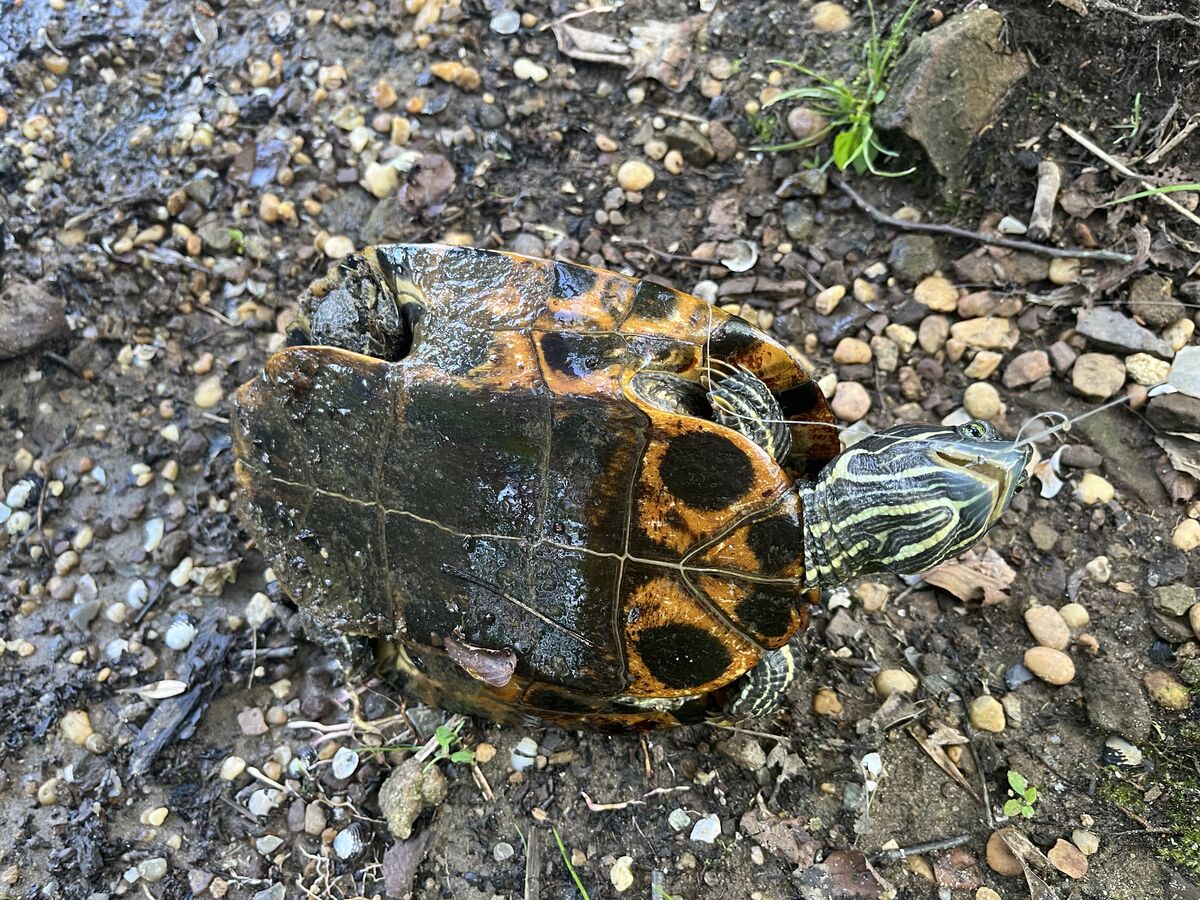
(232, 245), (1030, 732)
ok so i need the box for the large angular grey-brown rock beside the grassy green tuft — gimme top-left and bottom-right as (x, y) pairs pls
(875, 8), (1028, 187)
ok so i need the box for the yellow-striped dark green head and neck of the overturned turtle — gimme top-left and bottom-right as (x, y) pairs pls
(802, 421), (1031, 586)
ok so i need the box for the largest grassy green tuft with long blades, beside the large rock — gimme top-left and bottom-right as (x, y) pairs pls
(757, 0), (917, 178)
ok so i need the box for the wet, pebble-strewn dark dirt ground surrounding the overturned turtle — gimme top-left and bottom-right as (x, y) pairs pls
(0, 0), (1200, 900)
